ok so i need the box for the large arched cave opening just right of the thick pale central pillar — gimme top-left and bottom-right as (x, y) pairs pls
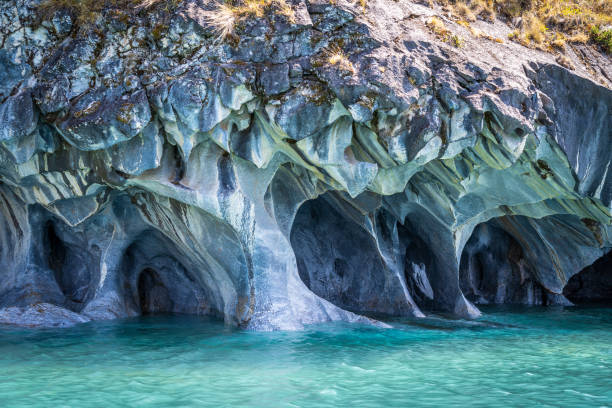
(291, 193), (424, 316)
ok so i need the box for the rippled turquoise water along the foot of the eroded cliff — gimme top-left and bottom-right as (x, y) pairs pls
(0, 308), (612, 407)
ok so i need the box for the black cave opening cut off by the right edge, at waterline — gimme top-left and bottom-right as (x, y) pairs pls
(563, 250), (612, 305)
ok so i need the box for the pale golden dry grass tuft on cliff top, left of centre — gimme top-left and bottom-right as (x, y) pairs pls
(206, 0), (295, 40)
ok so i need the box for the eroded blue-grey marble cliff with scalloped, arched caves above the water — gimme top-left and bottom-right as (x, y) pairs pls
(0, 0), (612, 330)
